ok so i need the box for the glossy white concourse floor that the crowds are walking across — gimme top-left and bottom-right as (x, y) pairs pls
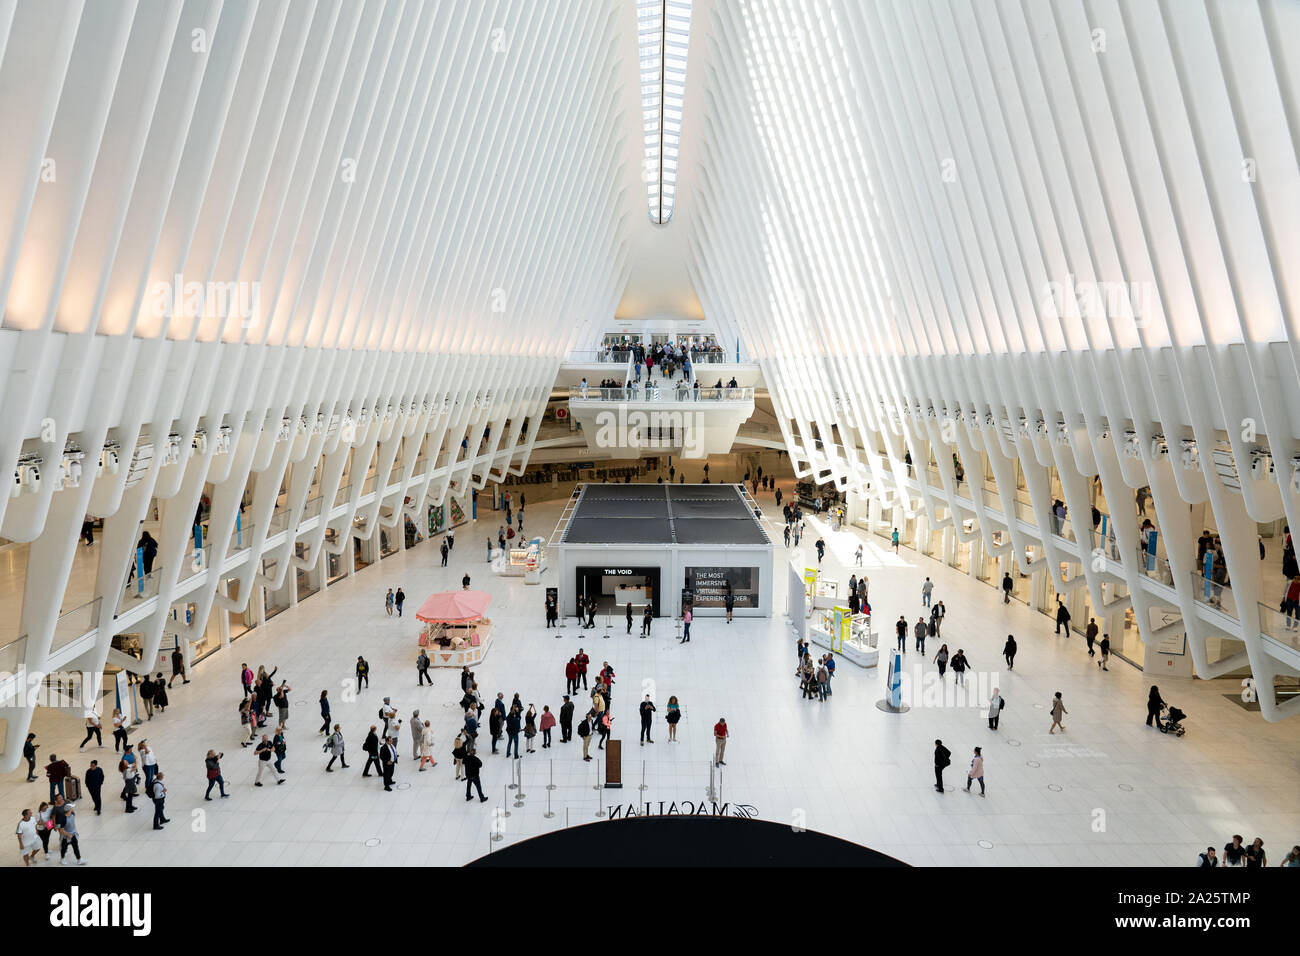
(0, 496), (1300, 866)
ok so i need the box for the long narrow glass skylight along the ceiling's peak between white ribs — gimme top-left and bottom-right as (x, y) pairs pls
(637, 0), (692, 225)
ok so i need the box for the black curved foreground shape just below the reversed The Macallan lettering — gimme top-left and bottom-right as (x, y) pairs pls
(465, 816), (907, 868)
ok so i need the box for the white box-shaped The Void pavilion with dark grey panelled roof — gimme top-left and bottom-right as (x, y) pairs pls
(558, 484), (772, 616)
